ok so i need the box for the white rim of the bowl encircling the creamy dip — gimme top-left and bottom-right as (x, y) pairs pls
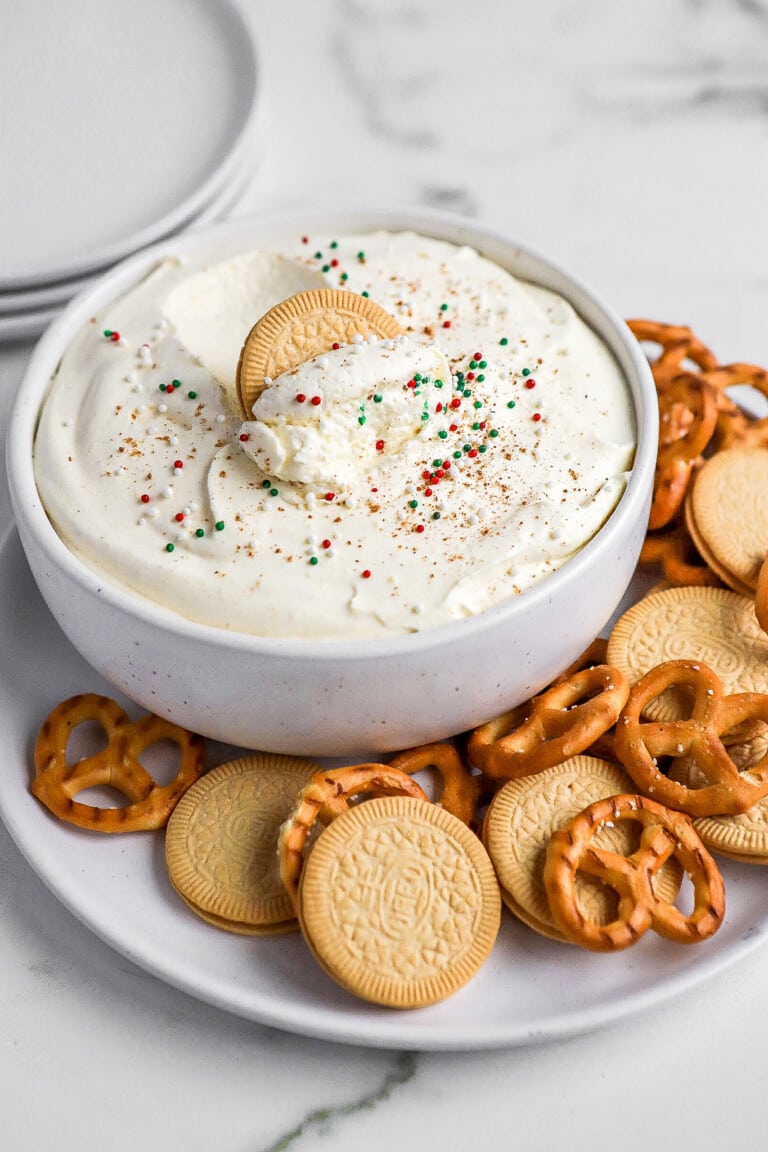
(6, 206), (659, 661)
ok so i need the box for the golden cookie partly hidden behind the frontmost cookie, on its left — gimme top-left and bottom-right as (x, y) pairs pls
(166, 752), (318, 935)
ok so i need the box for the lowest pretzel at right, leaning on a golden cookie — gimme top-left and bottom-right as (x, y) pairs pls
(543, 795), (725, 952)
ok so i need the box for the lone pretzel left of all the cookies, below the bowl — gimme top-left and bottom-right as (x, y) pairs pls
(30, 692), (205, 832)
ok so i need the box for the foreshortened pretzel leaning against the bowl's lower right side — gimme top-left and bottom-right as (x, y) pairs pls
(467, 665), (630, 780)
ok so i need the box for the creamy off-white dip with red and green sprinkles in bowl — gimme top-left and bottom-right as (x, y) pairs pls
(35, 232), (636, 639)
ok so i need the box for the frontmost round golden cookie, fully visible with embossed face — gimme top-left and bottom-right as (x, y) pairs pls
(299, 796), (501, 1008)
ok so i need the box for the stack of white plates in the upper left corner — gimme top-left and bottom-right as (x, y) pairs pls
(0, 0), (259, 340)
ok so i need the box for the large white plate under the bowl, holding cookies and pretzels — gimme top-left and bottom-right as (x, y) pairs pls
(0, 531), (768, 1049)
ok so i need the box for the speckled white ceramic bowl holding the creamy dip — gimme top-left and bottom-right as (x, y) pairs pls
(7, 211), (657, 756)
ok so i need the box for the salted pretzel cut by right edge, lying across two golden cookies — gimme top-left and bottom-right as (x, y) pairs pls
(615, 660), (768, 817)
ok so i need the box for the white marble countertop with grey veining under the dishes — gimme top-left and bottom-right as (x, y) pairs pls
(0, 0), (768, 1152)
